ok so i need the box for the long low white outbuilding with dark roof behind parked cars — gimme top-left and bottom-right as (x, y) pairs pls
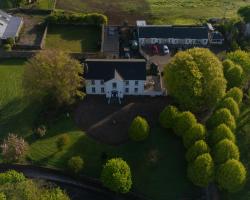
(137, 21), (225, 46)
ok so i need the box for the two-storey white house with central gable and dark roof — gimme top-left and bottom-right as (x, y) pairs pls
(84, 59), (146, 99)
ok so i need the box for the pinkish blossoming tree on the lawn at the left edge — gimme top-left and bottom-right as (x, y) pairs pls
(1, 134), (28, 163)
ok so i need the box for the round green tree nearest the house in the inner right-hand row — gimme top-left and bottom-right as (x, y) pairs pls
(159, 106), (179, 128)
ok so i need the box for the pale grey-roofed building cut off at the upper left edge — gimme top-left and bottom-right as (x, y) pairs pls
(0, 10), (23, 44)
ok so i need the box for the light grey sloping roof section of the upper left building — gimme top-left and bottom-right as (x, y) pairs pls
(3, 17), (23, 39)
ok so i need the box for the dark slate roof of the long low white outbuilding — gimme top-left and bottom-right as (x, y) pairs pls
(138, 26), (208, 39)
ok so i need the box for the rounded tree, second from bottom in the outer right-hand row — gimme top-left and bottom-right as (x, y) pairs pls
(212, 139), (240, 164)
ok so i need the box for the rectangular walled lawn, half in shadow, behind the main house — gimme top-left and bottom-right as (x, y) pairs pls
(46, 25), (101, 52)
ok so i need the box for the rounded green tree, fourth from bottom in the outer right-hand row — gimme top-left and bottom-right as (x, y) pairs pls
(207, 108), (236, 131)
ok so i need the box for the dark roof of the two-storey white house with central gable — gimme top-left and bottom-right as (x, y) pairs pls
(84, 59), (146, 82)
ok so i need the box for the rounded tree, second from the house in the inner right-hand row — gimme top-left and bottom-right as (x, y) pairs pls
(174, 111), (197, 136)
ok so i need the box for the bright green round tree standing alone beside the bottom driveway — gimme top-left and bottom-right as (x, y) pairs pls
(101, 158), (132, 193)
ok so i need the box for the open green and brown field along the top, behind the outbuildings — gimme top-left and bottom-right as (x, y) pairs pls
(56, 0), (250, 24)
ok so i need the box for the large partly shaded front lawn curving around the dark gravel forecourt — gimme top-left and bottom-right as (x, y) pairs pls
(0, 60), (197, 200)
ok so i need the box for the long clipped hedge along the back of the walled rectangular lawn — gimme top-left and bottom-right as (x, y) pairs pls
(46, 11), (108, 25)
